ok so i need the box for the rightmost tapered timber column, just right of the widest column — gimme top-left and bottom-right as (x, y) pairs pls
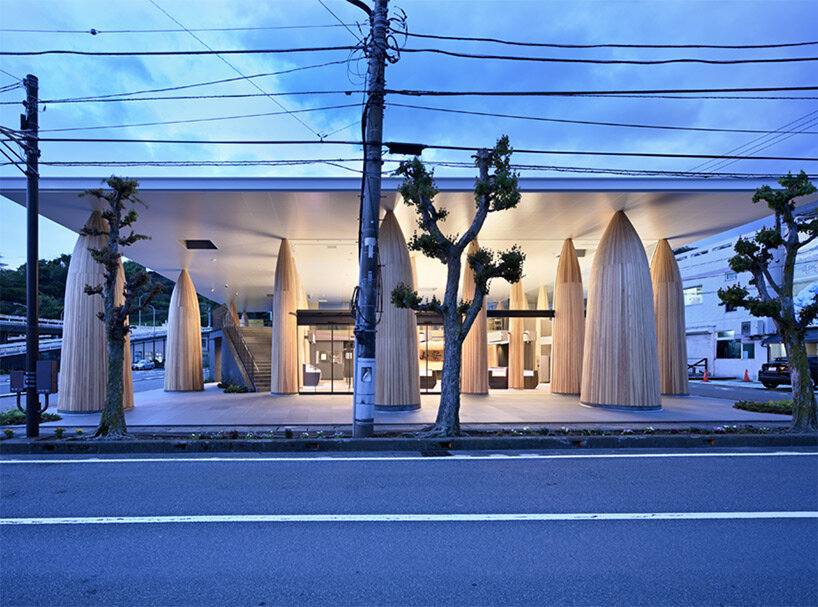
(650, 238), (689, 394)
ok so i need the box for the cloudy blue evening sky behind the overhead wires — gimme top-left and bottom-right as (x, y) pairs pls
(0, 0), (818, 267)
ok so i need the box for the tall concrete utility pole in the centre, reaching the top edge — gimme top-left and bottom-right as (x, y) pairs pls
(352, 0), (388, 436)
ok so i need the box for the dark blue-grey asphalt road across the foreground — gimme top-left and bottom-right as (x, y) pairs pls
(0, 450), (818, 607)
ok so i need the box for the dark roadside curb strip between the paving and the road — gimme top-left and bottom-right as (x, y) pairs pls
(0, 434), (818, 455)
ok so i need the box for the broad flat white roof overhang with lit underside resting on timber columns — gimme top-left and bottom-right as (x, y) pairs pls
(0, 177), (818, 310)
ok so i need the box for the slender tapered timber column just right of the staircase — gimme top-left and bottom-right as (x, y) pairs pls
(270, 238), (299, 394)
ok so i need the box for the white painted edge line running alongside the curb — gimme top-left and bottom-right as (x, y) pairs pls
(0, 451), (818, 466)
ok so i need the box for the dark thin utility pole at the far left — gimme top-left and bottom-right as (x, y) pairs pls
(20, 74), (40, 438)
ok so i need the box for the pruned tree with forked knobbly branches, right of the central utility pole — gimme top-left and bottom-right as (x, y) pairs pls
(391, 136), (525, 436)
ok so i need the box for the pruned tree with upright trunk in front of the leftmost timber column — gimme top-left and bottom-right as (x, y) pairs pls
(80, 176), (162, 438)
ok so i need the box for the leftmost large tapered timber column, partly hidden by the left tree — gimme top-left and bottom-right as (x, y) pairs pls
(58, 211), (108, 411)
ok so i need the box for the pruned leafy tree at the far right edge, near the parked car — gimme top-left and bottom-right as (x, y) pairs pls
(719, 171), (818, 432)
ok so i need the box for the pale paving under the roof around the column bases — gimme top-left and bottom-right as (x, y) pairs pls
(44, 384), (789, 428)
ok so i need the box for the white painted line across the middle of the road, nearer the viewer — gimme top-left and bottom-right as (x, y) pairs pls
(0, 511), (818, 526)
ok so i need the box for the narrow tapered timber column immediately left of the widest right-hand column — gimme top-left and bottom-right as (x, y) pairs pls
(551, 238), (585, 394)
